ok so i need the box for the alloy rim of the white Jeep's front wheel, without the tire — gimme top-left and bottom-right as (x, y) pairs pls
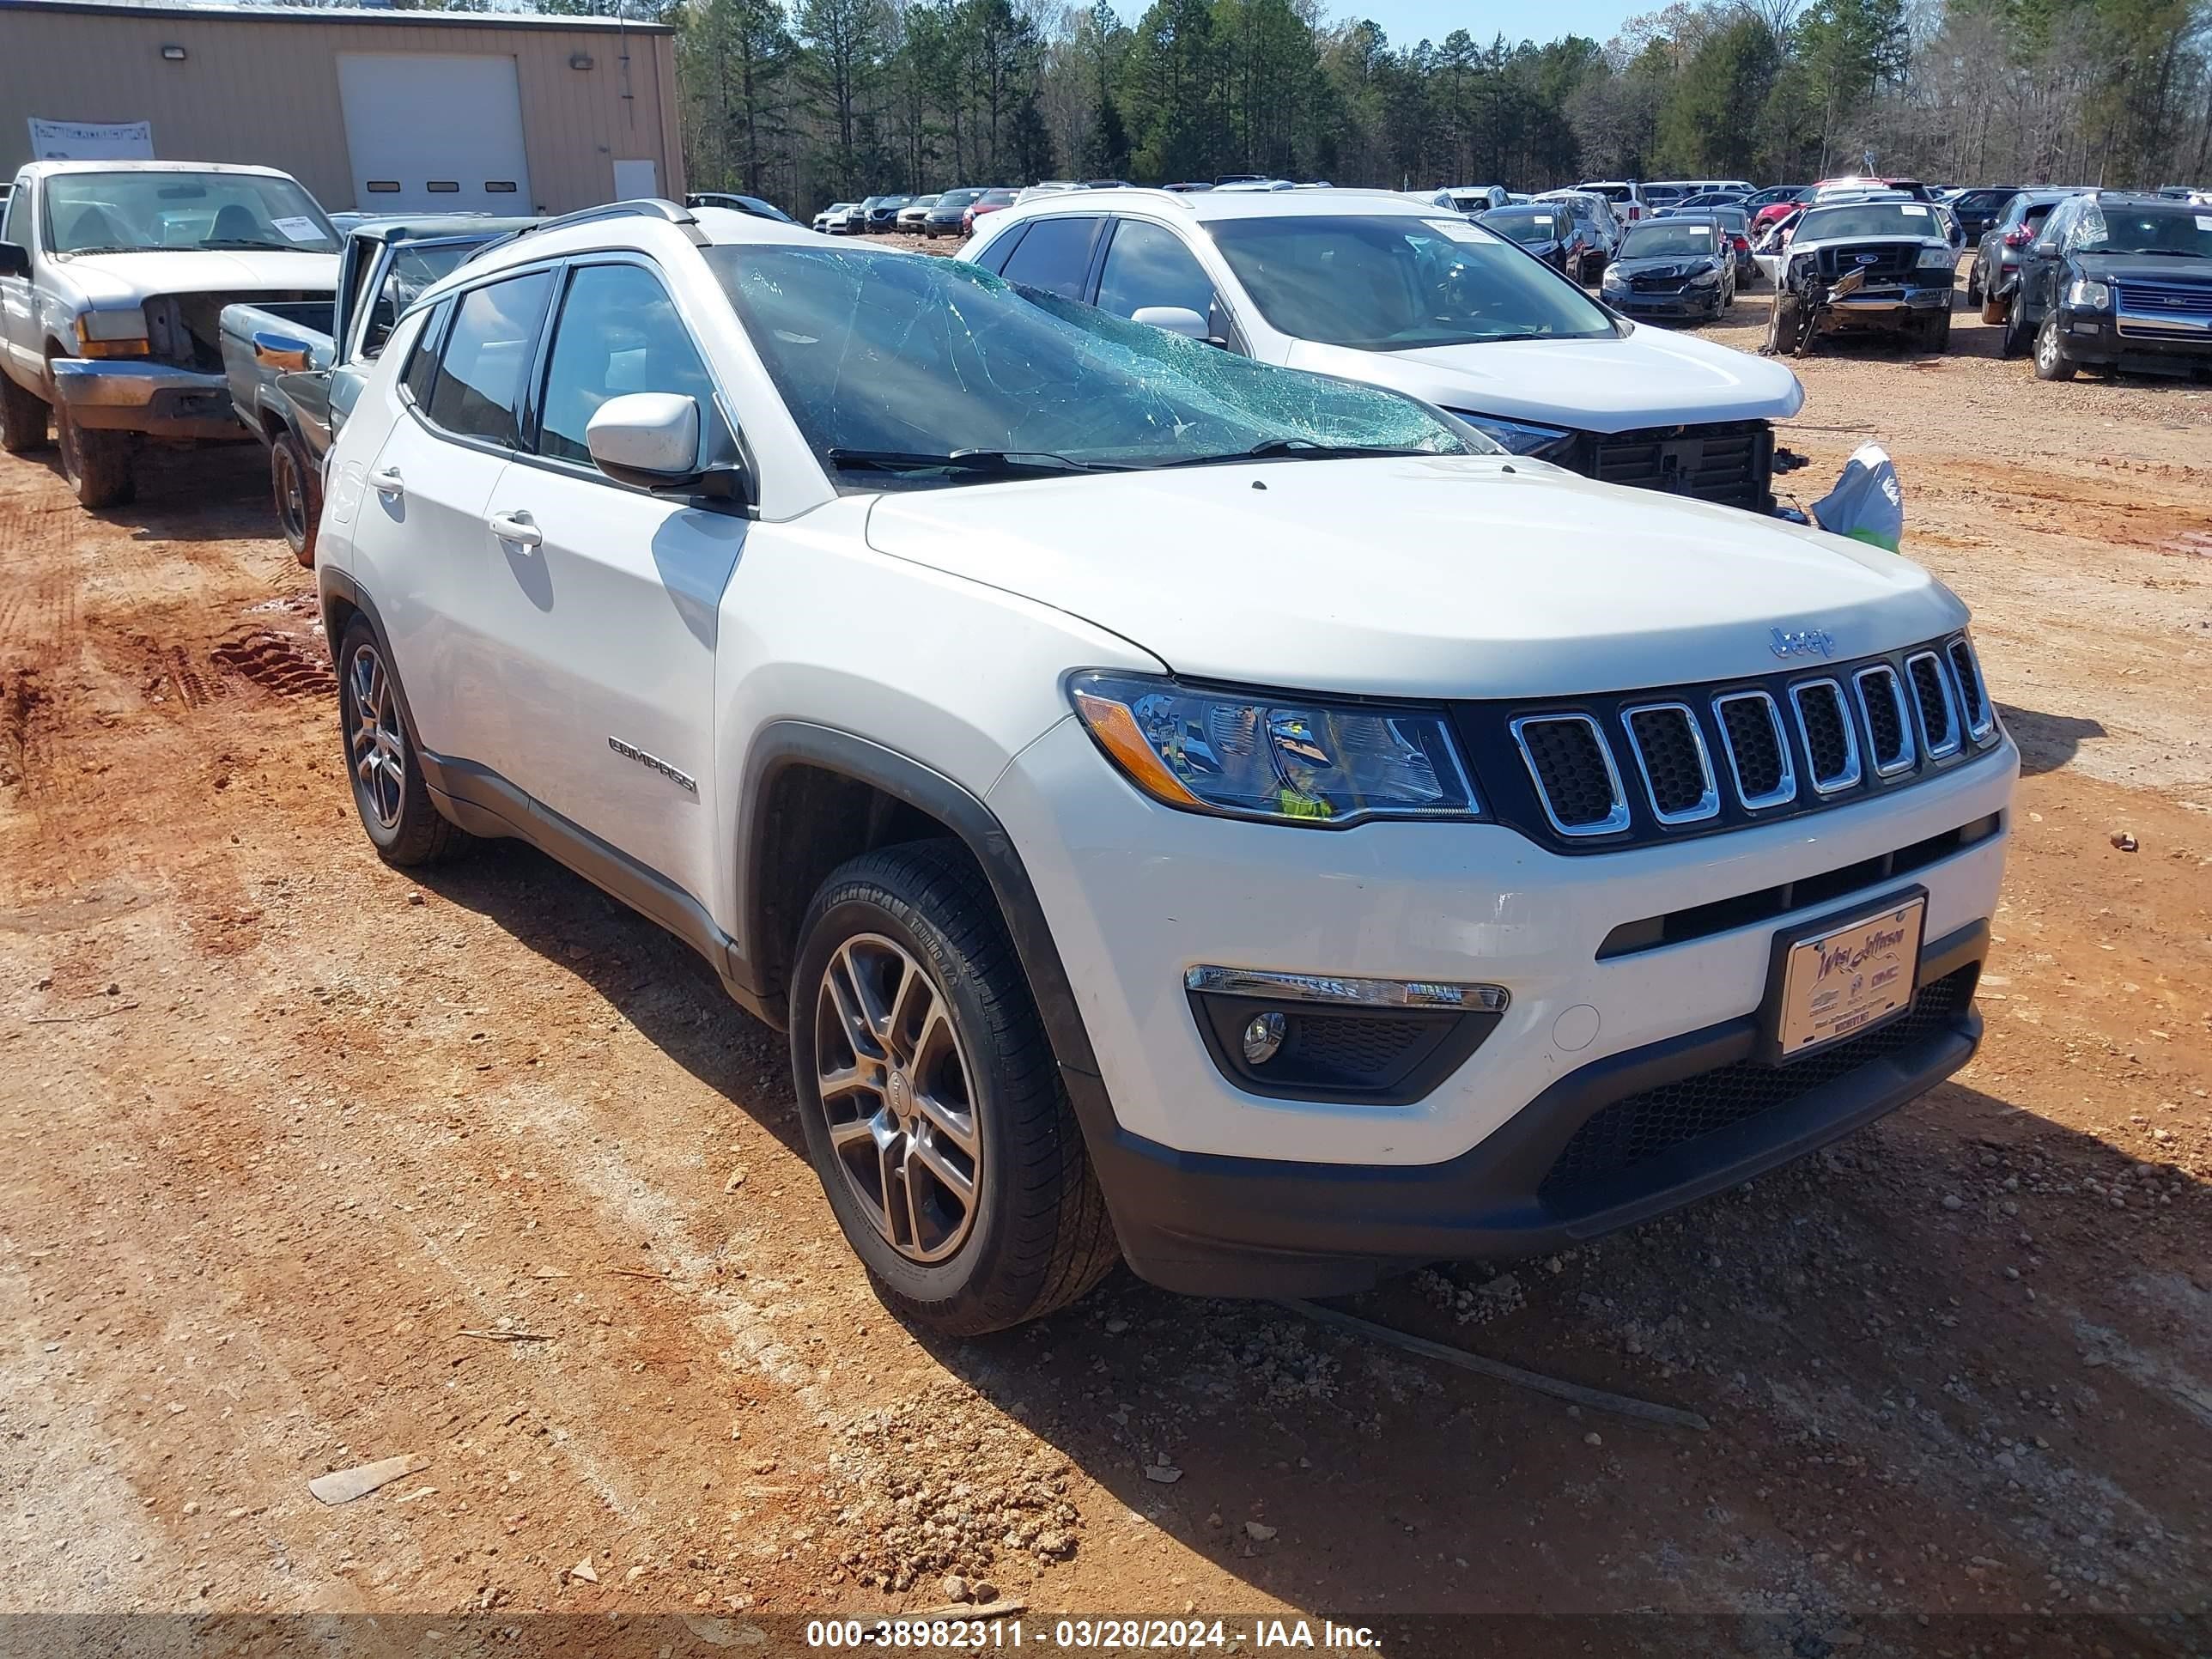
(814, 933), (982, 1265)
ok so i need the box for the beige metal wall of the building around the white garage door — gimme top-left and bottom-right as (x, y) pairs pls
(0, 7), (684, 212)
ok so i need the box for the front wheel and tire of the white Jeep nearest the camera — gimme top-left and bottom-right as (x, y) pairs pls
(792, 841), (1121, 1336)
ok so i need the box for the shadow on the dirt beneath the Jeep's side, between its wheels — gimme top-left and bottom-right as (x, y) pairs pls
(411, 841), (807, 1159)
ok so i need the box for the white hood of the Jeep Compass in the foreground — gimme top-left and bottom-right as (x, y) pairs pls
(867, 456), (1966, 699)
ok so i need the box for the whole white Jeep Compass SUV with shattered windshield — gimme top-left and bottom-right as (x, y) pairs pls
(319, 204), (2017, 1332)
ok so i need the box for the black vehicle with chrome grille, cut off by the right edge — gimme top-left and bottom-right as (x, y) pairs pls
(2002, 191), (2212, 380)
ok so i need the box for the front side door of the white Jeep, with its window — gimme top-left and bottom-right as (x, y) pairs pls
(469, 258), (750, 924)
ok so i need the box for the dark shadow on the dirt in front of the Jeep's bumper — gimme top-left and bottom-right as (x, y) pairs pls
(907, 1070), (2212, 1627)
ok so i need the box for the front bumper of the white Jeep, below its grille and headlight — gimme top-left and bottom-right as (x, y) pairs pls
(988, 719), (2020, 1294)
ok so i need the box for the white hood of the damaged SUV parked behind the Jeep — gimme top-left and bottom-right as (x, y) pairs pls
(1290, 325), (1805, 431)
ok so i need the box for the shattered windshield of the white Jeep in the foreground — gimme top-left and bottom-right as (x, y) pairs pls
(703, 243), (1484, 489)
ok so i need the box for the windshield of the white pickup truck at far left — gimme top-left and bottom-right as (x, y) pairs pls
(46, 168), (341, 254)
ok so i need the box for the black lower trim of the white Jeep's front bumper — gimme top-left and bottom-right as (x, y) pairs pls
(1088, 922), (1989, 1297)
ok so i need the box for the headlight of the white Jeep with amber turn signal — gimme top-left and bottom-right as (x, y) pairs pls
(1068, 672), (1478, 827)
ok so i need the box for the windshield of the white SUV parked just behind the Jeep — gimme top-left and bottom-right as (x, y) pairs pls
(1206, 212), (1614, 352)
